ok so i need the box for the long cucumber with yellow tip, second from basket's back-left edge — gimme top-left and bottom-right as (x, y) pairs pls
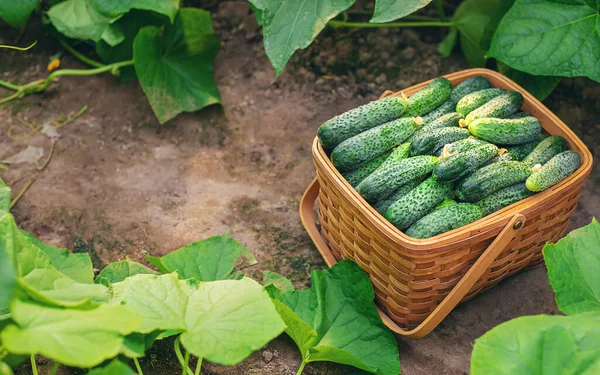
(331, 118), (420, 171)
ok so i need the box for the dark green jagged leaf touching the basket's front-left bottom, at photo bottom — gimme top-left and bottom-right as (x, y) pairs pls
(267, 260), (400, 375)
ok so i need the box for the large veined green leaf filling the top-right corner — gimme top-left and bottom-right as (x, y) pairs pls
(489, 0), (600, 82)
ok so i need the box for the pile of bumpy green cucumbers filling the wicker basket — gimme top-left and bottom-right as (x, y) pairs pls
(318, 76), (580, 238)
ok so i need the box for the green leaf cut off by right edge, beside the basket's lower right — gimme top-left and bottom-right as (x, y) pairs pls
(543, 219), (600, 315)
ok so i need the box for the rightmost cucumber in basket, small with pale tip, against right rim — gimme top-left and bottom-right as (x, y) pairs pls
(525, 150), (580, 192)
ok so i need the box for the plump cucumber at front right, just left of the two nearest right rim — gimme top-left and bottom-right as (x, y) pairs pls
(456, 161), (531, 202)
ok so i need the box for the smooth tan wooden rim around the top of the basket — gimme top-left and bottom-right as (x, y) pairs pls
(312, 68), (593, 253)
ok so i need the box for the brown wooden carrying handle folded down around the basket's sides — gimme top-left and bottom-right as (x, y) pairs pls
(300, 178), (525, 338)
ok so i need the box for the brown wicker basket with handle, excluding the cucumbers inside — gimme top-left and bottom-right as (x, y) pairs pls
(300, 69), (592, 337)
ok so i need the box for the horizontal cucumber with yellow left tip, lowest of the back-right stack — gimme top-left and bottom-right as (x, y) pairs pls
(469, 116), (542, 145)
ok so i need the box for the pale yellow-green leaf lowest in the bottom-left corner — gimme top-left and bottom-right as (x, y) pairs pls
(0, 300), (140, 367)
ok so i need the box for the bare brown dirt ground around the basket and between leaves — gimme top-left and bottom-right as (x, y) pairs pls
(0, 3), (600, 375)
